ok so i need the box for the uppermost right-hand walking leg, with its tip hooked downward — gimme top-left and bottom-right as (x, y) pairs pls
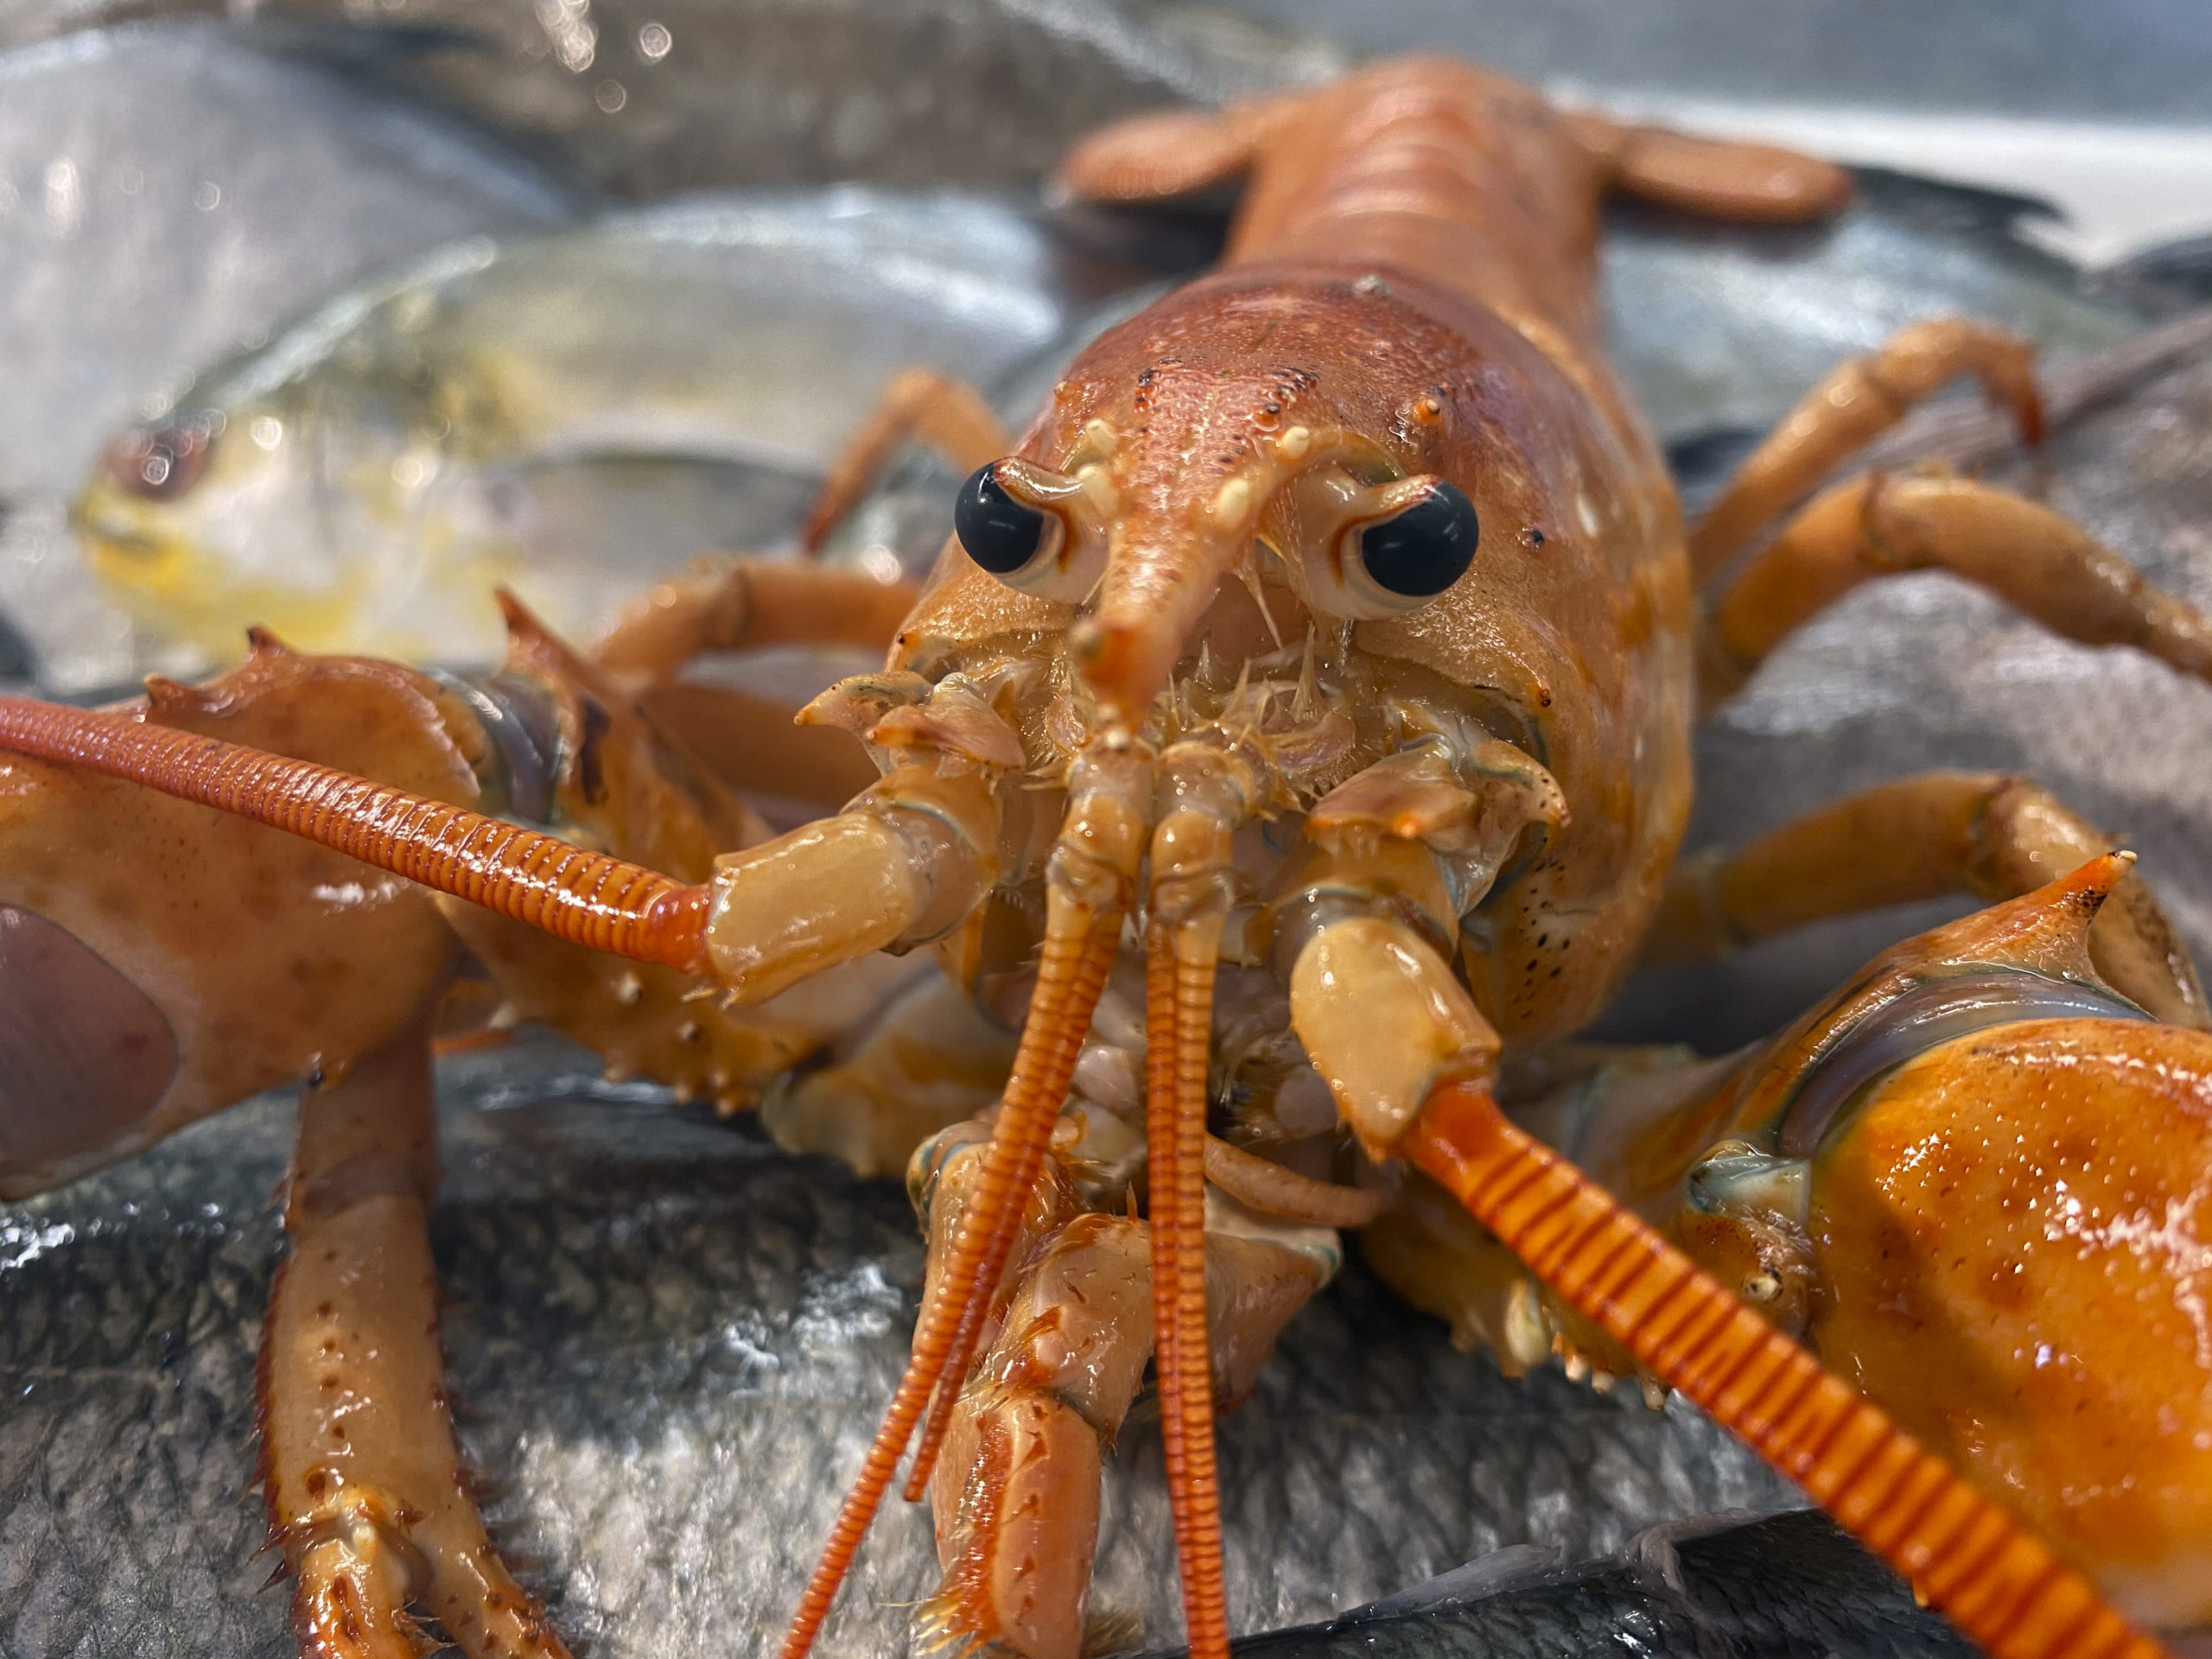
(1690, 316), (2044, 586)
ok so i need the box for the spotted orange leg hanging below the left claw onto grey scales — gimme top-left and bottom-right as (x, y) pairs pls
(259, 1022), (569, 1659)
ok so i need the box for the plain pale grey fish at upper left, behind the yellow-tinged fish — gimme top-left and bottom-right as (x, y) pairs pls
(0, 22), (577, 686)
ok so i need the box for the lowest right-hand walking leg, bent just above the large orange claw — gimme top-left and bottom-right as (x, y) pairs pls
(1643, 772), (2208, 1028)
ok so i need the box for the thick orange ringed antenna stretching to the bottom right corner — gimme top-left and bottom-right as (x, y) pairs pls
(1398, 1079), (2165, 1659)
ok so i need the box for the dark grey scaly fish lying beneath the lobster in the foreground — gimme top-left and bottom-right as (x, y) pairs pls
(0, 1038), (1798, 1659)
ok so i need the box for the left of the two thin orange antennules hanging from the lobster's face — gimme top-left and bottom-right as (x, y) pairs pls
(781, 750), (1150, 1659)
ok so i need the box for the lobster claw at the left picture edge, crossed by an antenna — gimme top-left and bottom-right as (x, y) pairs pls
(0, 635), (478, 1199)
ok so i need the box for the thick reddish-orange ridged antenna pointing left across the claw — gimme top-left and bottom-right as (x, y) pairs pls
(0, 696), (710, 973)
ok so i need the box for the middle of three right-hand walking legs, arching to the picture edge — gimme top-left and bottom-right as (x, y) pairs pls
(1701, 475), (2212, 706)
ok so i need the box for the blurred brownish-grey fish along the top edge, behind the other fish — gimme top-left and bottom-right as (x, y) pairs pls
(0, 0), (1350, 197)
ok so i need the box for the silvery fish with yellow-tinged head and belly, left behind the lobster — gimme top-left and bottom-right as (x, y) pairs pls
(78, 196), (1115, 677)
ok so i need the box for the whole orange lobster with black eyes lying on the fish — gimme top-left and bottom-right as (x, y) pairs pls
(0, 60), (2212, 1659)
